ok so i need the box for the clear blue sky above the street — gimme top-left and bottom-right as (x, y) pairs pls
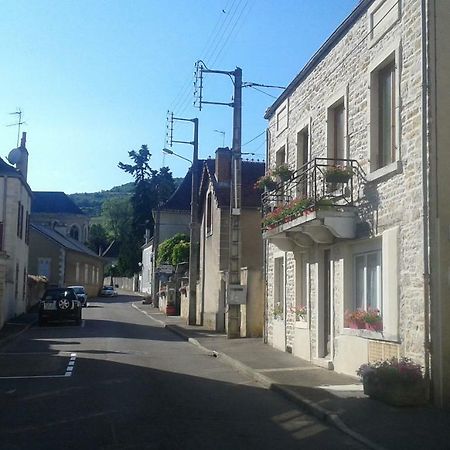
(0, 0), (358, 194)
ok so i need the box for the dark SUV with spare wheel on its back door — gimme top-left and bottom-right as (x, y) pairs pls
(39, 287), (81, 325)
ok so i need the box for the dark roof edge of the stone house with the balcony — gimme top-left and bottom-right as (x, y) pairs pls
(264, 0), (375, 119)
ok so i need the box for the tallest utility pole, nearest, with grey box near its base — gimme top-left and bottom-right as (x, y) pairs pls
(196, 61), (246, 338)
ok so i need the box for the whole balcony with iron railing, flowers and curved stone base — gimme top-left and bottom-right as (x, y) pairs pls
(262, 158), (365, 251)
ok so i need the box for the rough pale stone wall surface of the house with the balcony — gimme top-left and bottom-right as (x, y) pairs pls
(266, 0), (424, 374)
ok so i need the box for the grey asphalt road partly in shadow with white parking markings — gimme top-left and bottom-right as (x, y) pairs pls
(0, 296), (363, 450)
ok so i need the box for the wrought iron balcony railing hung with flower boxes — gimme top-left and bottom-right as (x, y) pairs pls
(262, 158), (365, 228)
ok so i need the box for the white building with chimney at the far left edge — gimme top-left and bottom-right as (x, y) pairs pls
(0, 133), (32, 328)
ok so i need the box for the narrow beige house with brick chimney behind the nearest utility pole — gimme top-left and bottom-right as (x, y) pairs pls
(196, 148), (265, 337)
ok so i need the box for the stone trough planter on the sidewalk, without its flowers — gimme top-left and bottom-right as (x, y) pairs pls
(363, 374), (427, 406)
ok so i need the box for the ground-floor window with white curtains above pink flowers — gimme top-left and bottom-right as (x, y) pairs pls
(353, 250), (382, 311)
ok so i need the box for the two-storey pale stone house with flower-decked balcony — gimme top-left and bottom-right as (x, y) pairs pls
(263, 0), (450, 406)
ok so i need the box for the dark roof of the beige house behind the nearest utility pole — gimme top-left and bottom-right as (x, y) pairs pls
(200, 155), (265, 208)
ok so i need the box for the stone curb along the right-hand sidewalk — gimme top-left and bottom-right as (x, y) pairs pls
(133, 304), (385, 450)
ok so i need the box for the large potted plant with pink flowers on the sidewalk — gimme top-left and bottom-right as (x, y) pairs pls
(356, 358), (427, 406)
